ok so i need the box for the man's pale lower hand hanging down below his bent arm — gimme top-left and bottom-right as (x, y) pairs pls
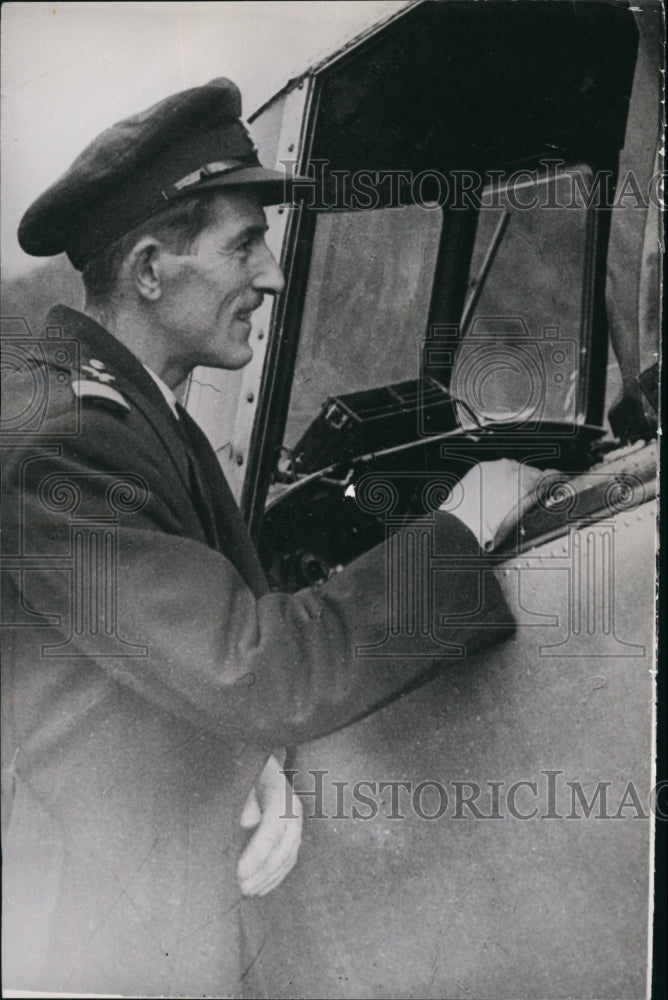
(237, 756), (303, 896)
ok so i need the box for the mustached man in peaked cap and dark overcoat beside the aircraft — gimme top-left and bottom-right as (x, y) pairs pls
(3, 79), (532, 996)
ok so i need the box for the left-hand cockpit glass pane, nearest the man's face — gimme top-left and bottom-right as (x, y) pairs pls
(283, 205), (442, 447)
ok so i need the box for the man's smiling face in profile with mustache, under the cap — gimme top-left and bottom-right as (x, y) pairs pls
(160, 189), (284, 369)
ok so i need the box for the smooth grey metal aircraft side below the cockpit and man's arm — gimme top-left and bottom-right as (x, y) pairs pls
(253, 502), (656, 998)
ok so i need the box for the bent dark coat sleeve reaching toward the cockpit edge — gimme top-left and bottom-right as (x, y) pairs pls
(5, 402), (513, 747)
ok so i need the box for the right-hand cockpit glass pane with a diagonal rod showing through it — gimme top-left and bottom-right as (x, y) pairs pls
(450, 168), (594, 426)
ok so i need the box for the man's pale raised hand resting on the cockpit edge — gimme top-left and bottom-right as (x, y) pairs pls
(440, 458), (546, 549)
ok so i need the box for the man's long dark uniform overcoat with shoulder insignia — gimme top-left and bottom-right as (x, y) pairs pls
(2, 307), (512, 996)
